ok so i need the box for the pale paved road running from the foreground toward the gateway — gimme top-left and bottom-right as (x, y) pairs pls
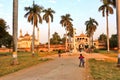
(0, 54), (89, 80)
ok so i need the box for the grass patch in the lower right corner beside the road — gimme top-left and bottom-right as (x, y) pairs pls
(89, 59), (120, 80)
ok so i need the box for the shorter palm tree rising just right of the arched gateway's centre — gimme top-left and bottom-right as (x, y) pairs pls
(85, 18), (98, 47)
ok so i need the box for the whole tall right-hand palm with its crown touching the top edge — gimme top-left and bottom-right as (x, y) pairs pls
(98, 0), (113, 52)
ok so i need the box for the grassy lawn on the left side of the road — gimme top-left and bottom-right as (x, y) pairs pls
(0, 52), (56, 76)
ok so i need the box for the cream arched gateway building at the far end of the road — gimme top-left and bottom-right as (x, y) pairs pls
(67, 33), (105, 51)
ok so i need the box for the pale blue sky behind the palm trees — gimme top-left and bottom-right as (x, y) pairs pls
(0, 0), (117, 43)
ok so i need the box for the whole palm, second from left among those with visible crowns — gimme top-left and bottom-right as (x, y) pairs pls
(43, 8), (55, 52)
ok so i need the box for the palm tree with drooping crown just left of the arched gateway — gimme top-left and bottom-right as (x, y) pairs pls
(60, 14), (73, 50)
